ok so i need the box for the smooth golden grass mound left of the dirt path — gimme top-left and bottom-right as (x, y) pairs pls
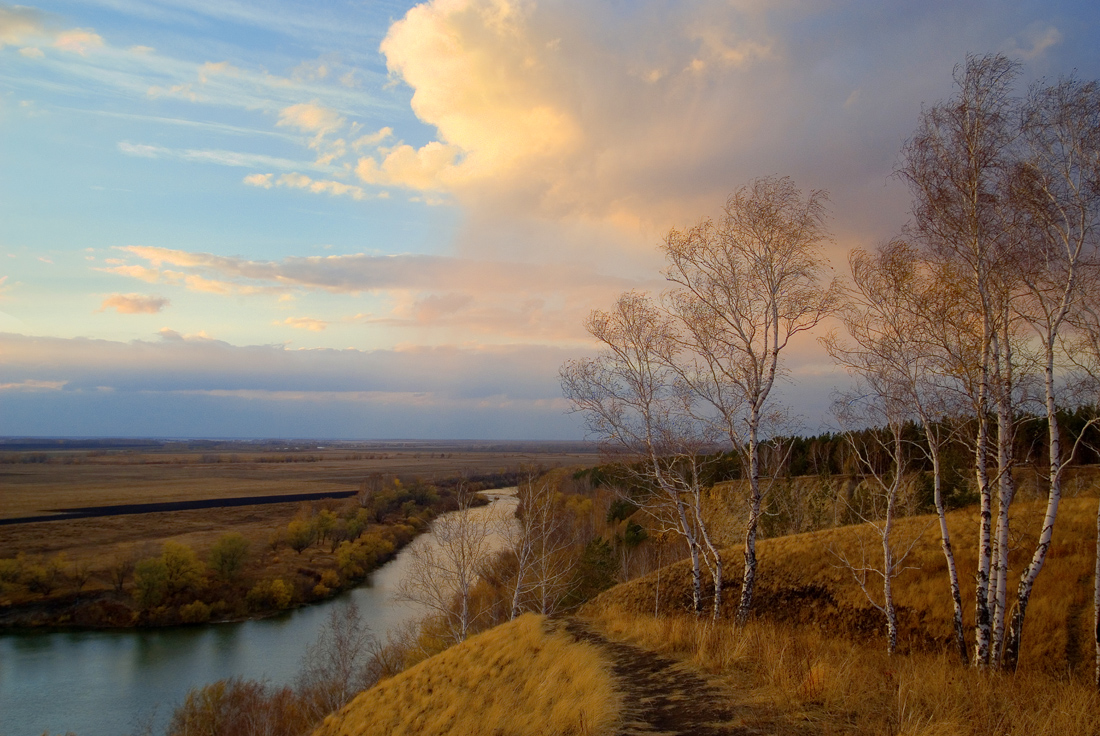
(315, 614), (622, 736)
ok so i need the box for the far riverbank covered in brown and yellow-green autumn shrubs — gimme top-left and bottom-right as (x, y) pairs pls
(0, 479), (510, 630)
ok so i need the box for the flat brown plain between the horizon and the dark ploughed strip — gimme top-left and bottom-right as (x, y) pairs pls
(0, 442), (596, 519)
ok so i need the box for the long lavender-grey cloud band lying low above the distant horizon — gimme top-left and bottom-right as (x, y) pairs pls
(0, 328), (574, 399)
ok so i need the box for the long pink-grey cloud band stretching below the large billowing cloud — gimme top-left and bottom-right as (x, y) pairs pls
(100, 245), (661, 343)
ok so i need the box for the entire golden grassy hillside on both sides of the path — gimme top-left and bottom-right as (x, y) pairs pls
(318, 473), (1100, 736)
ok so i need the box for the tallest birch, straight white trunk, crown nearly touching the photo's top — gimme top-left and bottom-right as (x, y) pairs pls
(899, 55), (1018, 667)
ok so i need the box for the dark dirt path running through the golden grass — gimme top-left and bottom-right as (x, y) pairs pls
(565, 619), (757, 736)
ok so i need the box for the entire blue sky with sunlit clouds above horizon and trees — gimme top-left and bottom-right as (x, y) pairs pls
(0, 0), (1100, 439)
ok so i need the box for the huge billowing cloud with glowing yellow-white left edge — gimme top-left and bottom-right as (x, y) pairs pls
(358, 0), (1082, 244)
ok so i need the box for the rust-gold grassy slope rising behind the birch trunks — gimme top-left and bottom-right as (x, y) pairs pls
(602, 490), (1098, 675)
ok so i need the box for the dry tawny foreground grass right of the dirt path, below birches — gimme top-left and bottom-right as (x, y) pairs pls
(587, 606), (1100, 736)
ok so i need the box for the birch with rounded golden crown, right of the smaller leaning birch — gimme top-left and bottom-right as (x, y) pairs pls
(664, 177), (836, 622)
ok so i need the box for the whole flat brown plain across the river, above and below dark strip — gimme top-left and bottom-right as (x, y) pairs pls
(0, 442), (597, 618)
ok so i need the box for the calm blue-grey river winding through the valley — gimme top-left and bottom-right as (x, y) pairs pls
(0, 488), (516, 736)
